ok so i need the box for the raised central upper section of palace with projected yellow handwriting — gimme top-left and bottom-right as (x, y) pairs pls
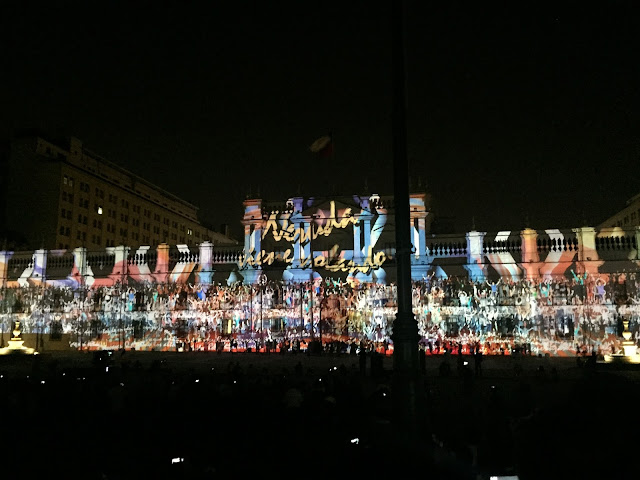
(239, 193), (431, 283)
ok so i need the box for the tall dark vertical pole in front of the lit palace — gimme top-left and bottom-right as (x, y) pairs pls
(391, 0), (426, 467)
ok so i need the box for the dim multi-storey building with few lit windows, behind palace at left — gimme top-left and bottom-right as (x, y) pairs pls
(4, 136), (237, 250)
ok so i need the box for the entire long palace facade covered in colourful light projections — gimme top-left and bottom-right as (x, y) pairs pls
(0, 189), (640, 355)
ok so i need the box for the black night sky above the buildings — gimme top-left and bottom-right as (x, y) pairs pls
(0, 1), (640, 238)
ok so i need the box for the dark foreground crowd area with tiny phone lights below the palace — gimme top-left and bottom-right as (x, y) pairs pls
(0, 351), (640, 480)
